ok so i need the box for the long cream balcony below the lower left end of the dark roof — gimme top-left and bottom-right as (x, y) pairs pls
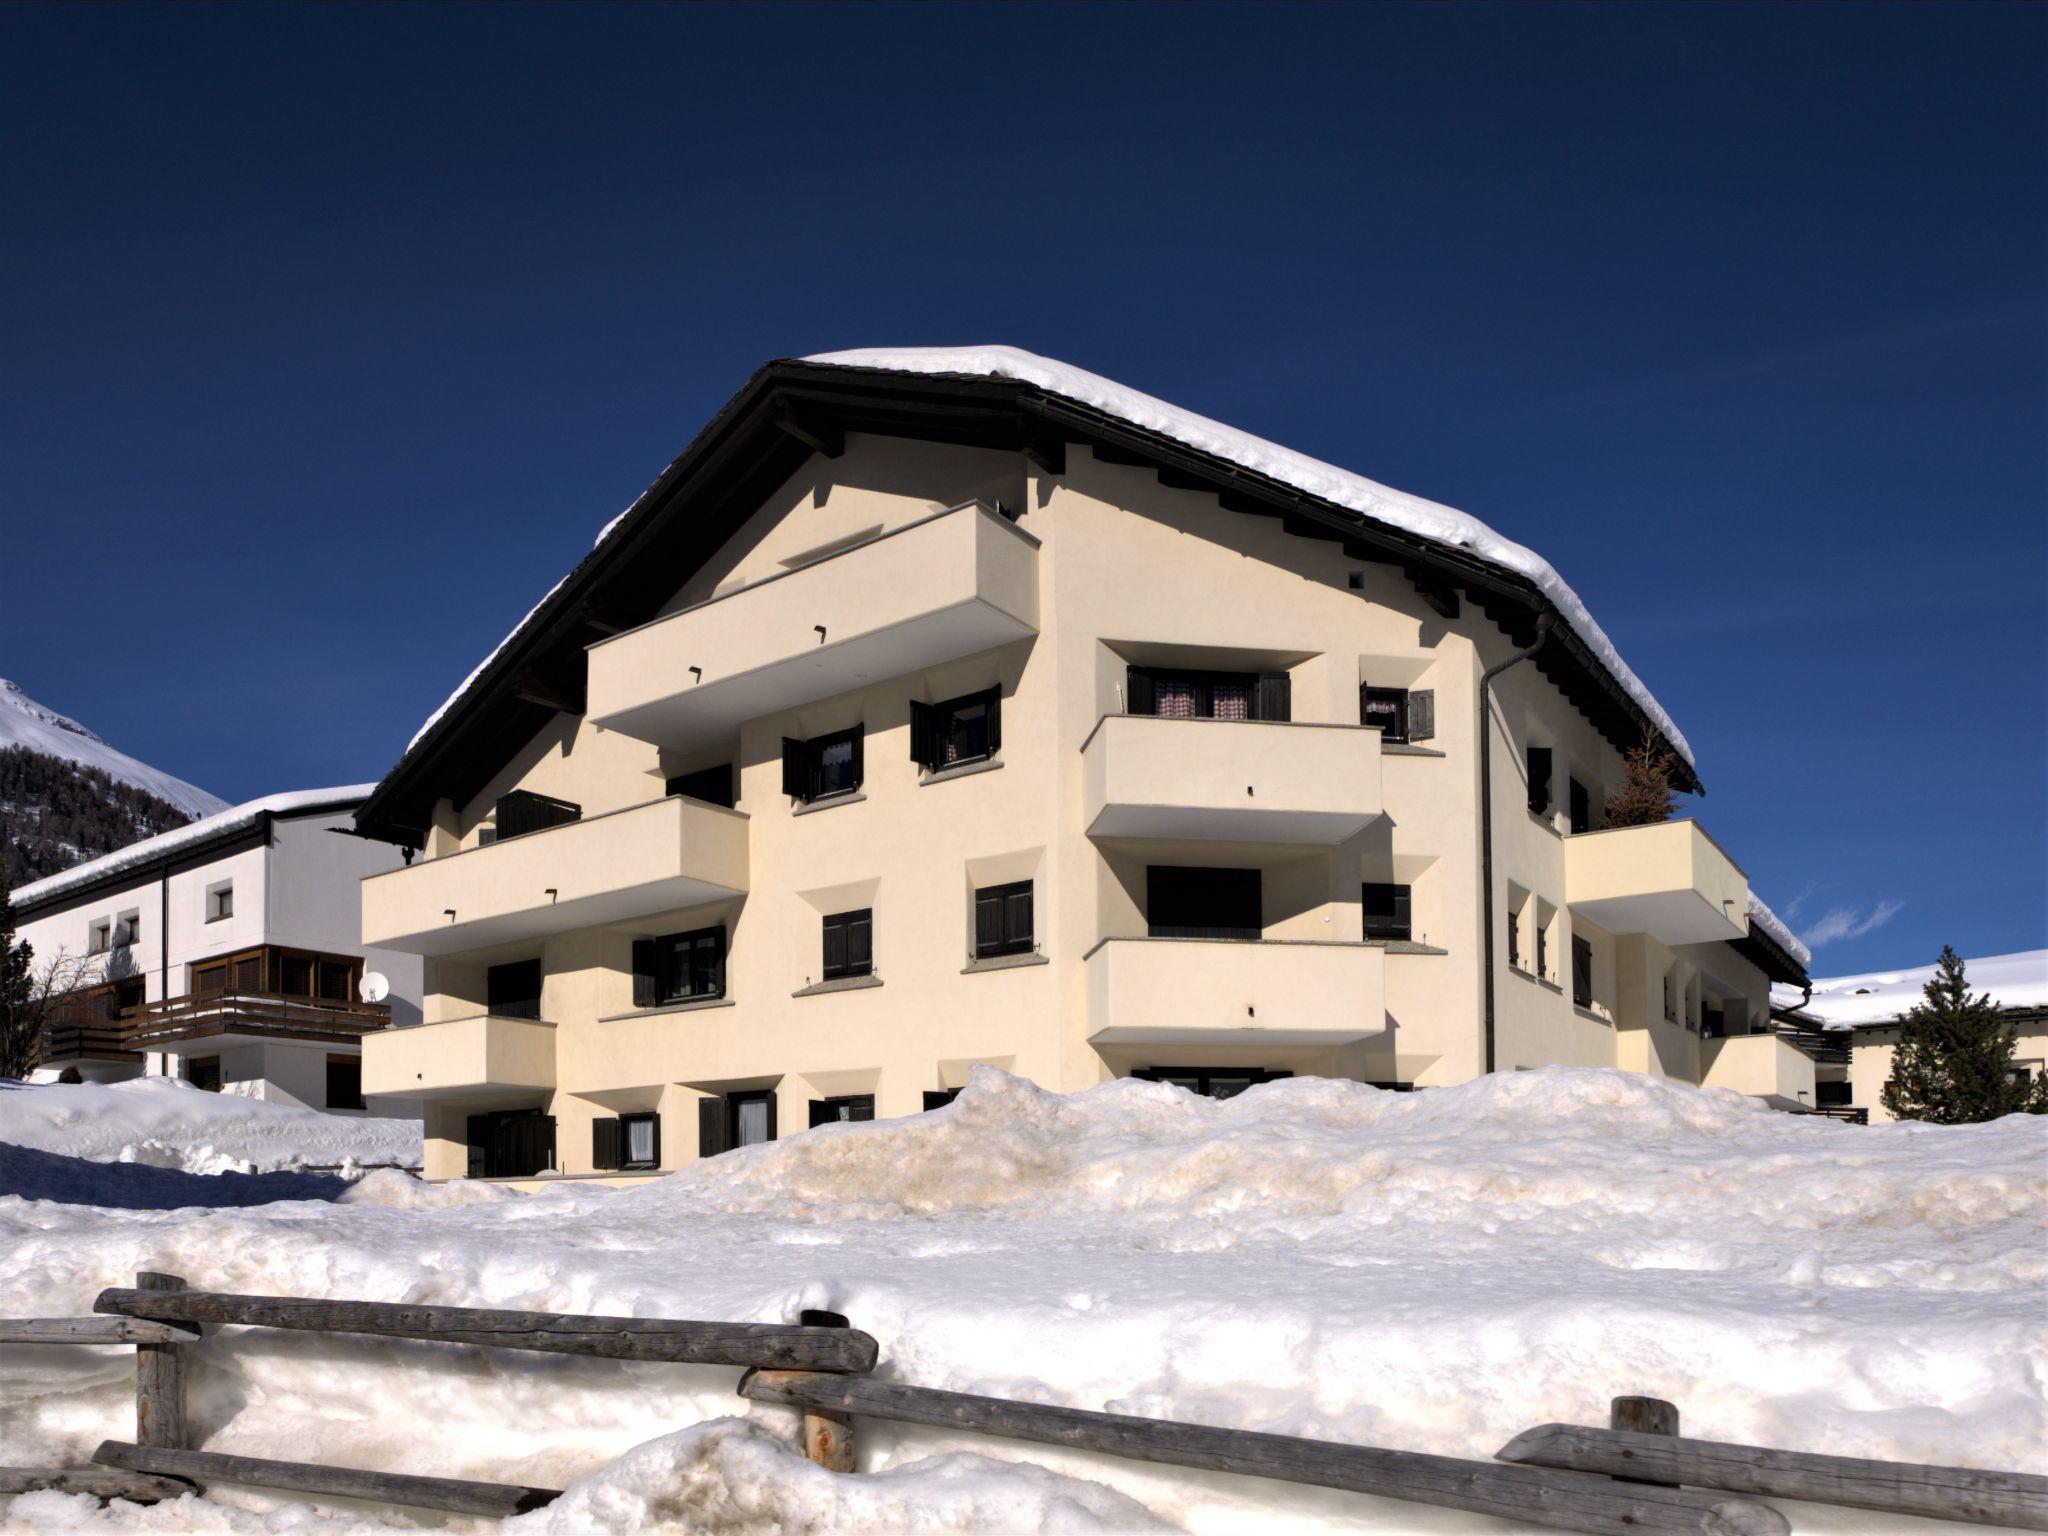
(362, 795), (748, 954)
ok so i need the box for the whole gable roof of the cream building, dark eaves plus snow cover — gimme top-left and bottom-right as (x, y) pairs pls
(356, 346), (1702, 842)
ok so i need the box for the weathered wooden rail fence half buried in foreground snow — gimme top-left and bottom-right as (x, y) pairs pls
(0, 1272), (2048, 1536)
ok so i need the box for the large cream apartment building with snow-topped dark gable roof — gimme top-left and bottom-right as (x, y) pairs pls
(356, 348), (1812, 1176)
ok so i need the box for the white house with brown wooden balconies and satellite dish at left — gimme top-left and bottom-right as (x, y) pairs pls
(12, 784), (420, 1114)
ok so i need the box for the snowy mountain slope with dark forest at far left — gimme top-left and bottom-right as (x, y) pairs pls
(0, 678), (227, 885)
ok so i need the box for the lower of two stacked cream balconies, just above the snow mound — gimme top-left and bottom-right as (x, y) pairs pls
(1085, 938), (1386, 1047)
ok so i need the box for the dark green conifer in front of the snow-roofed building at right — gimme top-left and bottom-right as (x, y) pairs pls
(1880, 944), (2048, 1124)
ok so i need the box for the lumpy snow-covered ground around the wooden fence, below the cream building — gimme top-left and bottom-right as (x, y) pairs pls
(0, 1069), (2048, 1532)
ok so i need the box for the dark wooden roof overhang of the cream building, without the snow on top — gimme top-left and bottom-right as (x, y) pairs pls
(356, 360), (1704, 844)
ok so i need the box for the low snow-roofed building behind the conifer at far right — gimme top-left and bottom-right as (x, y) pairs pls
(1780, 950), (2048, 1124)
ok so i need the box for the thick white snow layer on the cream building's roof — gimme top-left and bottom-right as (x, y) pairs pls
(805, 346), (1694, 764)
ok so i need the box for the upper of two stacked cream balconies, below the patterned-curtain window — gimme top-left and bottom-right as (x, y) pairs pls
(1081, 715), (1380, 846)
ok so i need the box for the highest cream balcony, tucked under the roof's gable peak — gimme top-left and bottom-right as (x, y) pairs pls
(588, 502), (1038, 750)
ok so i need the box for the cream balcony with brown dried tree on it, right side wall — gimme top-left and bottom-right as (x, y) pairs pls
(1565, 821), (1749, 944)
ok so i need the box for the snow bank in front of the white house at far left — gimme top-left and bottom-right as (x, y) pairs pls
(0, 1077), (420, 1194)
